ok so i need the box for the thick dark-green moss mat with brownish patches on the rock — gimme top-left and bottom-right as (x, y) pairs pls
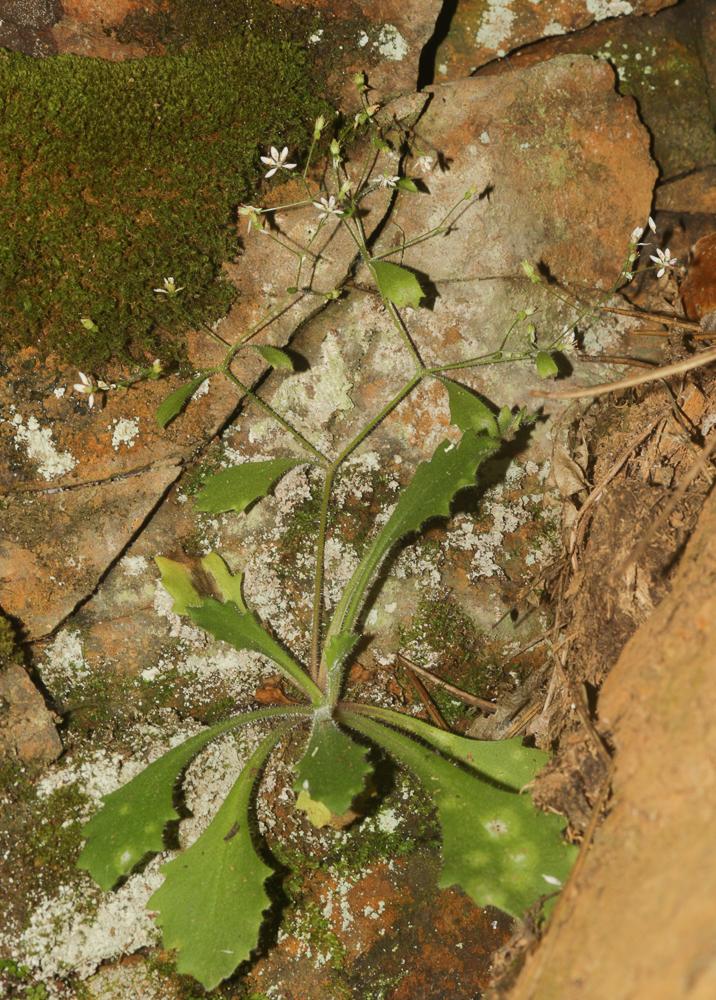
(0, 31), (320, 369)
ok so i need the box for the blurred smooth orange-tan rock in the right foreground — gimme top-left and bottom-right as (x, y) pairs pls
(509, 486), (716, 1000)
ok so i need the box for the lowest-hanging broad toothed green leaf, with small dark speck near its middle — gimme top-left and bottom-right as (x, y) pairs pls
(147, 726), (294, 990)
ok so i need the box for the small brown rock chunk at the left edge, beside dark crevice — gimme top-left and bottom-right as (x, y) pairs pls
(0, 664), (62, 764)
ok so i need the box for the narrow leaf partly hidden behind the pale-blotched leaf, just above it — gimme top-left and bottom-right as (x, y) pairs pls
(350, 705), (549, 792)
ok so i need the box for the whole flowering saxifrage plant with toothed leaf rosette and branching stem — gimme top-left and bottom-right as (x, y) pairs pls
(74, 88), (575, 989)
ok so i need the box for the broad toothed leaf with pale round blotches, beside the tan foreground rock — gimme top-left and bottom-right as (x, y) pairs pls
(341, 711), (577, 918)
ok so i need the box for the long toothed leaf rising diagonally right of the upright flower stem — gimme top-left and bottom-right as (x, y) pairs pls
(328, 430), (500, 639)
